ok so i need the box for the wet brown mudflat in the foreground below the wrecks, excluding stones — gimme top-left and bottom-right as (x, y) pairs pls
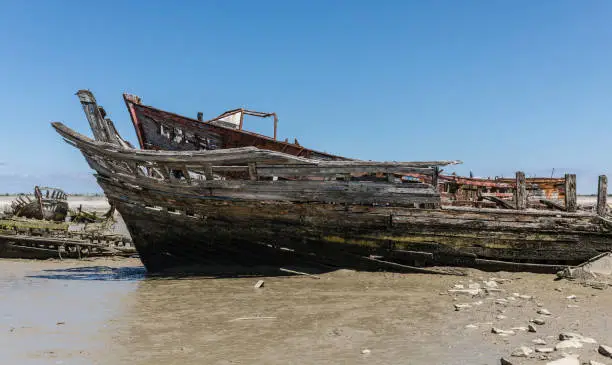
(0, 259), (612, 364)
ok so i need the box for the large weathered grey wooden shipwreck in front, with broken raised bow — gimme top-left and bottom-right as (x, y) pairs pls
(52, 91), (612, 272)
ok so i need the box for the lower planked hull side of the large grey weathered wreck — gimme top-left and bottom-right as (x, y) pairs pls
(99, 178), (612, 272)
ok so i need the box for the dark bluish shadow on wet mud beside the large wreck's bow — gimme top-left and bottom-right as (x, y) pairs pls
(28, 266), (146, 281)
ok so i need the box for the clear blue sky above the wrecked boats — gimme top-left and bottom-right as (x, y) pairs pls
(0, 0), (612, 193)
